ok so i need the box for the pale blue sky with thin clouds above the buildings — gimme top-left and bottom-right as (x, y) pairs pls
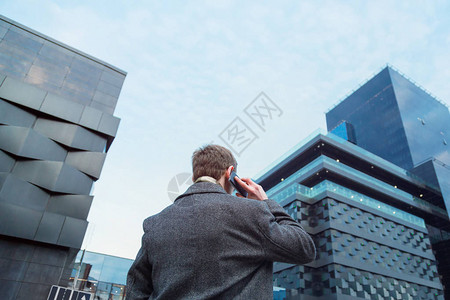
(0, 0), (450, 258)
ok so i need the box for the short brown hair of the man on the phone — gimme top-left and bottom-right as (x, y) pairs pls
(192, 145), (237, 181)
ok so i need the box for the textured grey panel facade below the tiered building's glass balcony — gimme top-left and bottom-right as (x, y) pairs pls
(273, 184), (444, 299)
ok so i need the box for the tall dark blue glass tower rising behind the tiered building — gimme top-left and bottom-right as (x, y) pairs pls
(326, 66), (450, 298)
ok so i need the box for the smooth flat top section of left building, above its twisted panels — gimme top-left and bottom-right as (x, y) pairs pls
(0, 16), (125, 115)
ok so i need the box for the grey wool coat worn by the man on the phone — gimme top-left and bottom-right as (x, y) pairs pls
(126, 182), (316, 300)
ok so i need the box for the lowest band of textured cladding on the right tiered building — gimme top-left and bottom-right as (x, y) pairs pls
(274, 264), (444, 300)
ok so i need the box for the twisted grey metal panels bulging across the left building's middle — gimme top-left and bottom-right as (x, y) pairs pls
(0, 77), (117, 248)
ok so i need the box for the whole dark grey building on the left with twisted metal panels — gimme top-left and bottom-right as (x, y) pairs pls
(0, 16), (126, 299)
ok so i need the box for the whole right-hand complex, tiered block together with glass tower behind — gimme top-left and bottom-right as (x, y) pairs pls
(257, 67), (450, 299)
